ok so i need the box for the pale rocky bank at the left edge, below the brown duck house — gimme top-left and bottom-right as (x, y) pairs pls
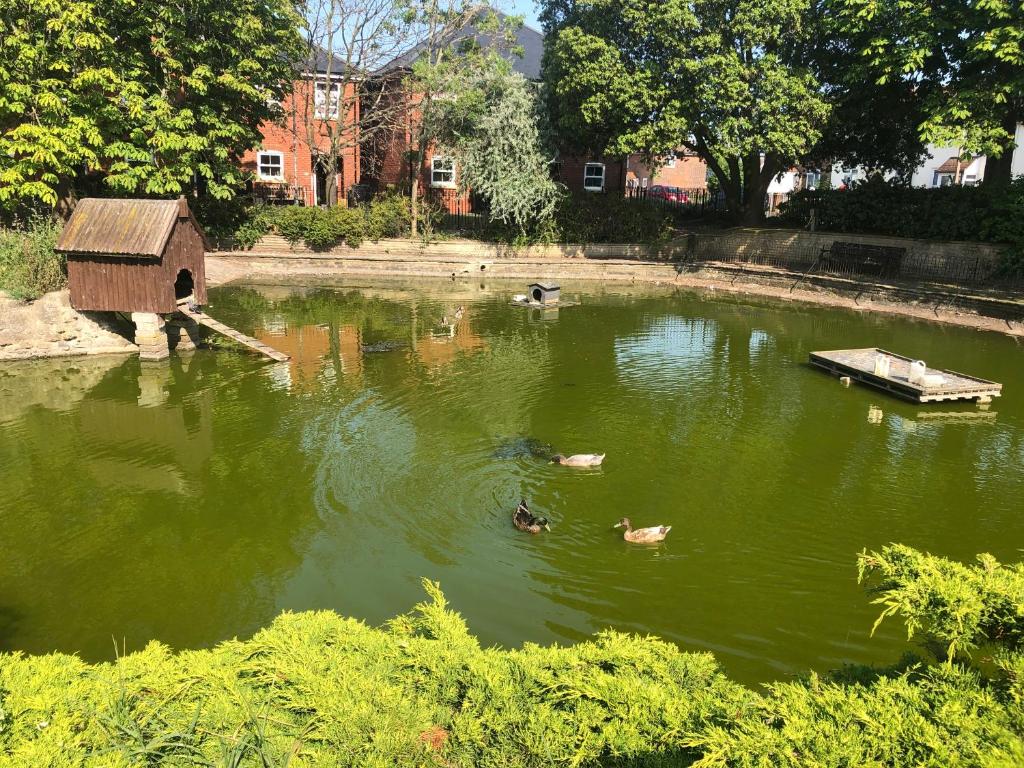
(0, 291), (137, 360)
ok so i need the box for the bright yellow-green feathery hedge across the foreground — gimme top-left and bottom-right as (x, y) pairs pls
(0, 547), (1024, 768)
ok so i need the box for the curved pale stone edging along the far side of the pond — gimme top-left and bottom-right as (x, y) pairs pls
(207, 251), (1024, 337)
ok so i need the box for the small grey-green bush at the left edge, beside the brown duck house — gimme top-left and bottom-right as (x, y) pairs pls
(0, 216), (68, 300)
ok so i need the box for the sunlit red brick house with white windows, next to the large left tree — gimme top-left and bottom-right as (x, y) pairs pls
(242, 51), (361, 206)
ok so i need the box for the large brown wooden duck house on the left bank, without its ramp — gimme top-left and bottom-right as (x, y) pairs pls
(56, 198), (207, 314)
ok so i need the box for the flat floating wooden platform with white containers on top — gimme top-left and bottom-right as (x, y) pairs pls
(810, 347), (1002, 402)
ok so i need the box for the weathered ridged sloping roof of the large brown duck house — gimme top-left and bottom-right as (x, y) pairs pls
(56, 198), (179, 258)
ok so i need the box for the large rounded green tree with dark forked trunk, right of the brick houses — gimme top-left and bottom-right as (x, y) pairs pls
(544, 0), (829, 224)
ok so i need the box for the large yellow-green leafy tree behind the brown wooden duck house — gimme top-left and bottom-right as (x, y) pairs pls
(0, 0), (301, 214)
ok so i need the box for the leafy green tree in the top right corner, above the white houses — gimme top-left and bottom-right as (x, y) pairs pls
(831, 0), (1024, 186)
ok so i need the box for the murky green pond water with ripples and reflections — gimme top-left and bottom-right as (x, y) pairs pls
(0, 281), (1024, 683)
